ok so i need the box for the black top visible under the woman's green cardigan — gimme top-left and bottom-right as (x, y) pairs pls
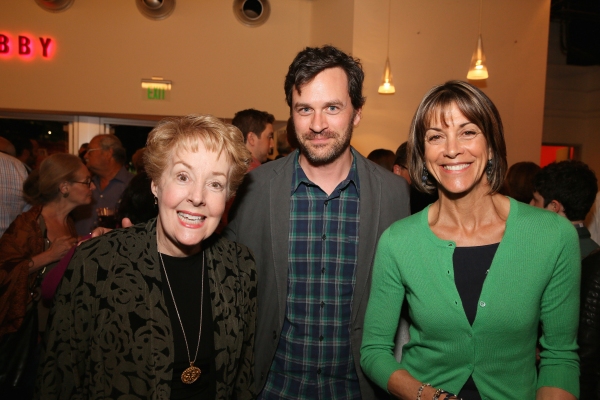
(452, 243), (500, 400)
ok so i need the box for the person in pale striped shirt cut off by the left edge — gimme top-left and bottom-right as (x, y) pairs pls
(0, 152), (29, 236)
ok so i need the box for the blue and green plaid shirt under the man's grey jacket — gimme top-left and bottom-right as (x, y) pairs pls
(260, 152), (361, 400)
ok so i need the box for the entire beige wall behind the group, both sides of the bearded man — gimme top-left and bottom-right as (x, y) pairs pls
(0, 0), (550, 163)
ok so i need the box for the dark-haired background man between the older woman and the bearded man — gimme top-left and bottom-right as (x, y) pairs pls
(231, 108), (275, 172)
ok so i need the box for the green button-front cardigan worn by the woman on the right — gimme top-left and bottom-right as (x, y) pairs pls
(361, 199), (581, 400)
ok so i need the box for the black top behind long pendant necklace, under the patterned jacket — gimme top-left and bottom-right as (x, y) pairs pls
(161, 252), (215, 399)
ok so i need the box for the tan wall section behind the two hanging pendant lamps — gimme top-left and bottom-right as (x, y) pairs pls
(354, 0), (550, 164)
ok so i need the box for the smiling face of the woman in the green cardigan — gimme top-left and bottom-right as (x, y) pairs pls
(425, 104), (492, 194)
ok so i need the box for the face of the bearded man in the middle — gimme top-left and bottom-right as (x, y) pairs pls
(292, 67), (362, 165)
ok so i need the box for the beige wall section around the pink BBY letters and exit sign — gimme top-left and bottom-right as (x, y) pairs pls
(0, 0), (311, 119)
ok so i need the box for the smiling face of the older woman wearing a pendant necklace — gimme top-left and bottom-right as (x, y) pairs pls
(152, 142), (230, 257)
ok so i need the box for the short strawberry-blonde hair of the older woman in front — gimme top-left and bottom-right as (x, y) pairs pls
(144, 114), (252, 198)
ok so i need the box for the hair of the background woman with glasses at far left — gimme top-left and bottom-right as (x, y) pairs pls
(23, 153), (83, 206)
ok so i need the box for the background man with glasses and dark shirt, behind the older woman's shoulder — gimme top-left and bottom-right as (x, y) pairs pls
(73, 135), (133, 235)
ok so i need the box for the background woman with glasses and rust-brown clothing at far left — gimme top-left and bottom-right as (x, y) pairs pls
(0, 153), (94, 398)
